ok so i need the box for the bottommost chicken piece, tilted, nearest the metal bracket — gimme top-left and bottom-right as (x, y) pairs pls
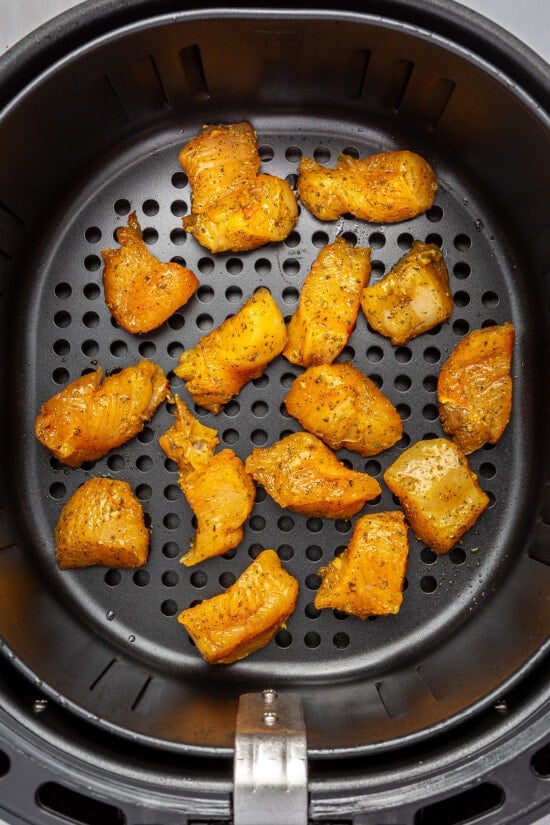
(178, 550), (298, 665)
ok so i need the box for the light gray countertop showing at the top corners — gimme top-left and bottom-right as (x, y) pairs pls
(0, 0), (550, 825)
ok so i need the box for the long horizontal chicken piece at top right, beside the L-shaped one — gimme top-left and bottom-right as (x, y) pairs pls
(298, 151), (437, 223)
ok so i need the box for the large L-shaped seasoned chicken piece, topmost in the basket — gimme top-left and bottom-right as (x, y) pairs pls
(179, 123), (298, 252)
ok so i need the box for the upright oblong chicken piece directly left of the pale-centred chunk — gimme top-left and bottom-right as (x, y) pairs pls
(283, 238), (371, 367)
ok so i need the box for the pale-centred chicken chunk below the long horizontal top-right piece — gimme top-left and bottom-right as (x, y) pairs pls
(361, 241), (453, 345)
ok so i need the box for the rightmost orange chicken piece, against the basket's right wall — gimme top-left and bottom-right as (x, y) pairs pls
(437, 323), (515, 454)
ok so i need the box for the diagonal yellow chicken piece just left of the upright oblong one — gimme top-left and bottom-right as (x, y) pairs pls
(174, 287), (286, 413)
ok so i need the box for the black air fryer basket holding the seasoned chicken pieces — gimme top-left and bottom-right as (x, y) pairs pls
(0, 2), (550, 823)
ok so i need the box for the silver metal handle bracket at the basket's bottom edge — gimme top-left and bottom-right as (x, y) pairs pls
(233, 689), (308, 825)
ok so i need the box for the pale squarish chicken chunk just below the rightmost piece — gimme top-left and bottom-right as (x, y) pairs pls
(384, 438), (489, 553)
